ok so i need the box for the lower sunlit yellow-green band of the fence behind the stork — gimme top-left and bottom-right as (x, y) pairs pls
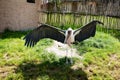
(39, 13), (120, 30)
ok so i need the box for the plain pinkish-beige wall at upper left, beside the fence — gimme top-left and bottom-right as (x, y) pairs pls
(0, 0), (40, 32)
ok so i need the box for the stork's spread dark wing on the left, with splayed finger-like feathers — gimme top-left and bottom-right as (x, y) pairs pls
(24, 24), (65, 47)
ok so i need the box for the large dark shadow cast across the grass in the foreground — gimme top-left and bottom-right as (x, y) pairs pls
(16, 58), (88, 80)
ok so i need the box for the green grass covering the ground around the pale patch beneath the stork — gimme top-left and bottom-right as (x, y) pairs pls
(0, 31), (120, 80)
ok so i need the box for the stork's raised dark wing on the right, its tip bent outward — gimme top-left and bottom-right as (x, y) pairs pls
(74, 20), (103, 42)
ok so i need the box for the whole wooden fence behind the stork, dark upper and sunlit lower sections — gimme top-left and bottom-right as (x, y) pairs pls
(39, 2), (120, 30)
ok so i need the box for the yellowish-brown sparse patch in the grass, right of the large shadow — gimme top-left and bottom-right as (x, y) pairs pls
(85, 53), (120, 80)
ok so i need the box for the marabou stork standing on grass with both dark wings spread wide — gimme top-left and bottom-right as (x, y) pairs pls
(24, 20), (103, 63)
